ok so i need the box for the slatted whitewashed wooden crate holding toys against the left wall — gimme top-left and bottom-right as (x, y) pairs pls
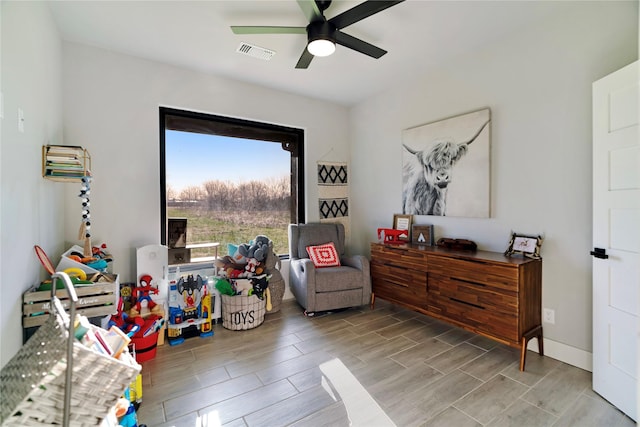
(22, 274), (120, 329)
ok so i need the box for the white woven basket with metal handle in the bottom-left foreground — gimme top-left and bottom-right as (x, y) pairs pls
(0, 273), (140, 427)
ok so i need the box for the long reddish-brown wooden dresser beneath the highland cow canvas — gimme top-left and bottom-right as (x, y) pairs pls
(371, 243), (544, 371)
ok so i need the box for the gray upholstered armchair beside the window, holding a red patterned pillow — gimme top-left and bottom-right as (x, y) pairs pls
(289, 223), (371, 314)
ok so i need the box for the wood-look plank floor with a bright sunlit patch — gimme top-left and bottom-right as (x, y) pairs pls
(138, 300), (635, 427)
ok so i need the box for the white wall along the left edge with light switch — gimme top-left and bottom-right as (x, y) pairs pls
(0, 1), (65, 366)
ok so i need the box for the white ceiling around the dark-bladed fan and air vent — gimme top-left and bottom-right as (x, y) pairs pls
(48, 0), (575, 105)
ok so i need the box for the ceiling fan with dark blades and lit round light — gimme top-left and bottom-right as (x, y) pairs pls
(231, 0), (404, 68)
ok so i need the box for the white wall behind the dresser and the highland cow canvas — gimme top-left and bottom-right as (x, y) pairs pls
(351, 2), (638, 368)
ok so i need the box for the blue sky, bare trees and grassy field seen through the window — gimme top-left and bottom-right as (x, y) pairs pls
(165, 130), (291, 258)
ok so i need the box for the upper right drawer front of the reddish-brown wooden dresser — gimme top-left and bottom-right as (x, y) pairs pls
(429, 256), (518, 292)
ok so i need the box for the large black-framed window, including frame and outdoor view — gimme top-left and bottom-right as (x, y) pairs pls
(160, 107), (304, 259)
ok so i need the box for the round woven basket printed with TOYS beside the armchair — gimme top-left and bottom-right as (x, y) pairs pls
(220, 295), (266, 331)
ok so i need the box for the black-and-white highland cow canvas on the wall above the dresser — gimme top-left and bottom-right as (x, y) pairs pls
(402, 108), (491, 218)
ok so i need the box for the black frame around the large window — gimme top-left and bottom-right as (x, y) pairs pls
(159, 107), (305, 245)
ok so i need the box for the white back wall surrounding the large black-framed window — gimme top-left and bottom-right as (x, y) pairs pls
(63, 43), (348, 281)
